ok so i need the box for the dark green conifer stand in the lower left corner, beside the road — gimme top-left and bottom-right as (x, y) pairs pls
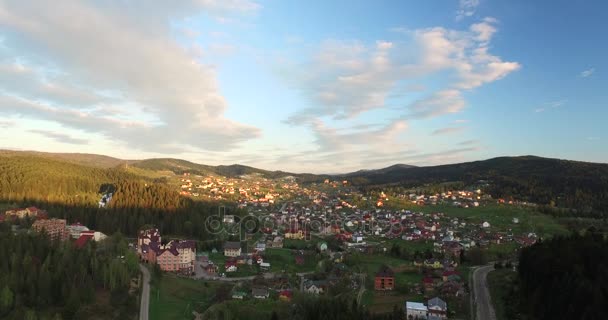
(0, 231), (138, 320)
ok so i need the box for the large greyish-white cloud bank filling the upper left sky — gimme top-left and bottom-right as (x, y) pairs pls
(0, 0), (260, 150)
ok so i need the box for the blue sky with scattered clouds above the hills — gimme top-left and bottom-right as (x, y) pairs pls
(0, 0), (608, 173)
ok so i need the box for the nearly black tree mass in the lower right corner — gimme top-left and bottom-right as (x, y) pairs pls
(511, 230), (608, 320)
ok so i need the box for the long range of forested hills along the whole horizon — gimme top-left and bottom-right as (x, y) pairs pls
(0, 151), (608, 212)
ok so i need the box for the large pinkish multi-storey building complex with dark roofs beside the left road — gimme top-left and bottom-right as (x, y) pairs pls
(137, 229), (196, 275)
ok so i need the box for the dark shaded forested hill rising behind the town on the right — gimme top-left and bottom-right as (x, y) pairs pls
(348, 156), (608, 216)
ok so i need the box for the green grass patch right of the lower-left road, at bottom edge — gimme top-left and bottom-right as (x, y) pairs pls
(150, 274), (223, 320)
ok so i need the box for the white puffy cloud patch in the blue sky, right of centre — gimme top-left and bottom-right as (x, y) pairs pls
(288, 18), (520, 124)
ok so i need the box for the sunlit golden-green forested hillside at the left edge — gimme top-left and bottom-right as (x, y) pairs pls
(0, 154), (180, 209)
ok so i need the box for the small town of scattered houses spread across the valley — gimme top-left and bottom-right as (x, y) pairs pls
(0, 173), (551, 319)
